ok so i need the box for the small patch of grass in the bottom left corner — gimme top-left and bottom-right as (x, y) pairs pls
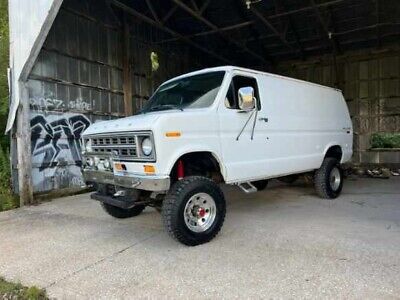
(0, 277), (49, 300)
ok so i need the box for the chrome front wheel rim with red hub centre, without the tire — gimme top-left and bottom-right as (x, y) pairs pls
(183, 193), (217, 232)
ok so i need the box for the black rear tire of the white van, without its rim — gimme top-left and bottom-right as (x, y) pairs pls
(314, 157), (343, 199)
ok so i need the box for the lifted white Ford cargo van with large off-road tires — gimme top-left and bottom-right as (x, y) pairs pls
(83, 66), (353, 245)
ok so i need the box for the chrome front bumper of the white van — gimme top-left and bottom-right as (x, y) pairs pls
(83, 169), (171, 192)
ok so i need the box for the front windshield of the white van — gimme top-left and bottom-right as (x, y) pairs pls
(141, 71), (225, 113)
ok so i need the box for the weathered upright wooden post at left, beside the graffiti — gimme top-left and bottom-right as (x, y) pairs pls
(17, 81), (35, 206)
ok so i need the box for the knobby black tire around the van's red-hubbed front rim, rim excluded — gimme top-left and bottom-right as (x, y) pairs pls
(162, 176), (226, 246)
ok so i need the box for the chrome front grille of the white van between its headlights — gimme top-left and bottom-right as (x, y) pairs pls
(90, 135), (138, 160)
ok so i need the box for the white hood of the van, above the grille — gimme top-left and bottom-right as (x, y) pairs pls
(82, 113), (162, 136)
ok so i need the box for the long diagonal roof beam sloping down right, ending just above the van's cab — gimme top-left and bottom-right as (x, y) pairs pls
(112, 0), (231, 64)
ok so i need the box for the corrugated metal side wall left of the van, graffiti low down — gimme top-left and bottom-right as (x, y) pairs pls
(28, 0), (200, 192)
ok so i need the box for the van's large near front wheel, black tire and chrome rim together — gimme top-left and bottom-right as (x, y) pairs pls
(162, 176), (226, 246)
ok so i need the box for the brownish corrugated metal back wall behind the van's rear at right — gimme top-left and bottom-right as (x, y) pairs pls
(279, 48), (400, 163)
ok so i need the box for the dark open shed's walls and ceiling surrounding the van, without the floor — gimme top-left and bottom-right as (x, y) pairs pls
(6, 0), (400, 202)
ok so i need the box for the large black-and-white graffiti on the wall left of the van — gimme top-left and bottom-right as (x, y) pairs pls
(30, 113), (90, 190)
